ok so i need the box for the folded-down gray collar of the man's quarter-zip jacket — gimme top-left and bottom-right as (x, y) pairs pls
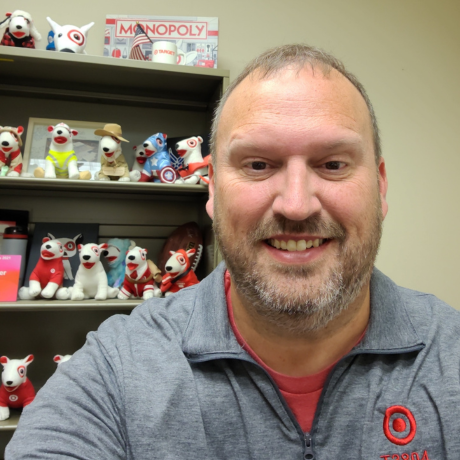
(183, 262), (424, 361)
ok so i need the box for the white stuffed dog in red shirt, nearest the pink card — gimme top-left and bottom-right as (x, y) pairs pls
(19, 237), (69, 300)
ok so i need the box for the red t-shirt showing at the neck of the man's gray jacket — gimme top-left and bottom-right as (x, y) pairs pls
(225, 271), (364, 432)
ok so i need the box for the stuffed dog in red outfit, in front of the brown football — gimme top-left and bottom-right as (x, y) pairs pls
(160, 249), (199, 297)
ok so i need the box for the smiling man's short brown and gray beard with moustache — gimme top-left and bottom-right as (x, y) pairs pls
(214, 196), (383, 335)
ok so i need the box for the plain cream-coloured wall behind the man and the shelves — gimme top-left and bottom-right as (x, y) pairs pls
(0, 0), (460, 309)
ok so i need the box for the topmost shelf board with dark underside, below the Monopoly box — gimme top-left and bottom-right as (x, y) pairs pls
(0, 46), (230, 111)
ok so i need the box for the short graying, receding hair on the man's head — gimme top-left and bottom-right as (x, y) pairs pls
(210, 44), (381, 164)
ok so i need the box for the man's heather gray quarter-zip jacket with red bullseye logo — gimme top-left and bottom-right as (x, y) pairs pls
(6, 264), (460, 460)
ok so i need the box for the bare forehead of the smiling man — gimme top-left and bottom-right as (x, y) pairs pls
(217, 66), (372, 145)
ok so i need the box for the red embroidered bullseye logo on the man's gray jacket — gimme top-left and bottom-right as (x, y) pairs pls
(383, 406), (417, 446)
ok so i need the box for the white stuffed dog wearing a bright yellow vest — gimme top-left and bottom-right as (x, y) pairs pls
(34, 123), (91, 180)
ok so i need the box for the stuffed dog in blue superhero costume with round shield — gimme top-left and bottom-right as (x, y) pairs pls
(139, 133), (177, 184)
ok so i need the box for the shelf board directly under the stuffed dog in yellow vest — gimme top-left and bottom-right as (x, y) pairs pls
(0, 177), (208, 196)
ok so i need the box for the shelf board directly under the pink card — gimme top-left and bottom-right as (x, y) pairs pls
(0, 299), (143, 312)
